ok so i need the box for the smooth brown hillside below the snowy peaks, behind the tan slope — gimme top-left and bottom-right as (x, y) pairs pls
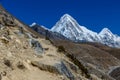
(51, 39), (120, 80)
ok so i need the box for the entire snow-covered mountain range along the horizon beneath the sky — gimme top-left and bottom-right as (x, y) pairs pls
(31, 14), (120, 48)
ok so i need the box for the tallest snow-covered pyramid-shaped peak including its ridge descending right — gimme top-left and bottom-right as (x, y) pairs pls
(51, 14), (98, 42)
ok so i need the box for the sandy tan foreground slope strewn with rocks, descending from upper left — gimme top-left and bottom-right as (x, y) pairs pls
(0, 6), (99, 80)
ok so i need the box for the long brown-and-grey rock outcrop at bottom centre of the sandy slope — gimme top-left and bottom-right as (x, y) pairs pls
(31, 61), (75, 80)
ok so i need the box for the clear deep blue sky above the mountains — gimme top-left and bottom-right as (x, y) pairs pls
(0, 0), (120, 35)
